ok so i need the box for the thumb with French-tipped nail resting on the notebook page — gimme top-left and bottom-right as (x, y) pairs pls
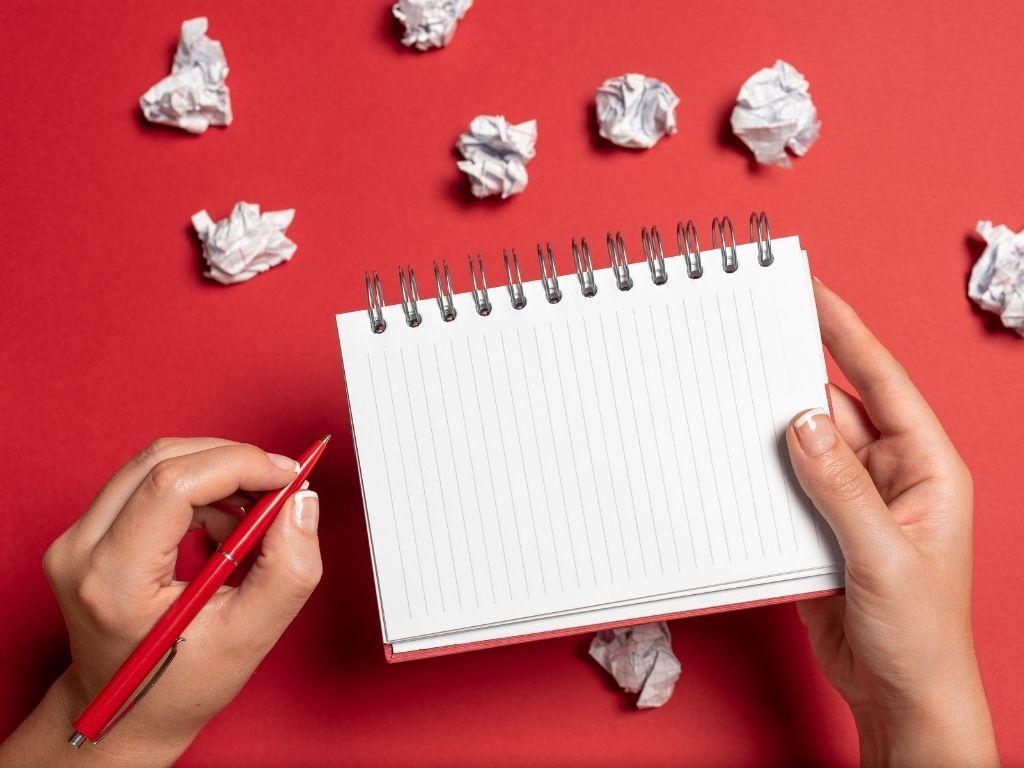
(785, 409), (900, 575)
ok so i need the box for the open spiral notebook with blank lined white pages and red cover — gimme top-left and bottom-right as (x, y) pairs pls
(337, 214), (843, 660)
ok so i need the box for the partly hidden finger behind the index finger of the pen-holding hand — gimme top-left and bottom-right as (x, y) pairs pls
(72, 437), (238, 549)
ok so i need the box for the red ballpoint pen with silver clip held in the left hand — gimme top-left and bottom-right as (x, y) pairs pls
(69, 435), (331, 748)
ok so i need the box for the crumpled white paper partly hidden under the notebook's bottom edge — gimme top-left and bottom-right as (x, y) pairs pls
(590, 622), (682, 709)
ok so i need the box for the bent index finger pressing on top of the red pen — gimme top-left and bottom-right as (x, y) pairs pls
(93, 444), (299, 583)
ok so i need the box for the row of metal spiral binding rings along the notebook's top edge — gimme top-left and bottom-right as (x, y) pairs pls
(365, 211), (775, 334)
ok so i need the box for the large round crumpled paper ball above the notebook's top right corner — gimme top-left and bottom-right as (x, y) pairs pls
(730, 59), (821, 168)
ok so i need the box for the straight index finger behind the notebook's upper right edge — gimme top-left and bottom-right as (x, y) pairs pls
(813, 280), (938, 434)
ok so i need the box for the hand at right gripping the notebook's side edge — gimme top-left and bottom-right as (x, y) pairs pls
(786, 282), (998, 766)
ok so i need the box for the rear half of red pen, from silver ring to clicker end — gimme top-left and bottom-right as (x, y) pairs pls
(75, 553), (234, 741)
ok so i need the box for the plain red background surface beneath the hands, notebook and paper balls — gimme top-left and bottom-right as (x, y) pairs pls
(0, 0), (1024, 766)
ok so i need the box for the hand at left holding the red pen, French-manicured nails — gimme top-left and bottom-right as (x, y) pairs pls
(0, 438), (322, 766)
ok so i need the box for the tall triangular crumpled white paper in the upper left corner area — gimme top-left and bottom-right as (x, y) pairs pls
(138, 16), (231, 133)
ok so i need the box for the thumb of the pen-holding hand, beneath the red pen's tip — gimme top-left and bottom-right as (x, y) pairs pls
(228, 490), (323, 648)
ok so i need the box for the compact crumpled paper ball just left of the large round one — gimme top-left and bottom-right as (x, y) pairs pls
(595, 74), (679, 150)
